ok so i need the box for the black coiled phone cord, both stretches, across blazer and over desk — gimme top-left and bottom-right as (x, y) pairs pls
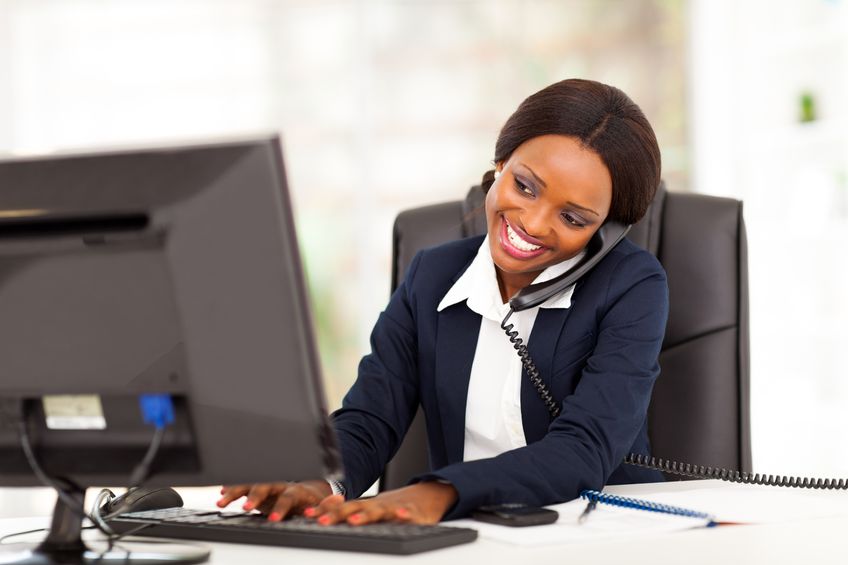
(501, 308), (848, 490)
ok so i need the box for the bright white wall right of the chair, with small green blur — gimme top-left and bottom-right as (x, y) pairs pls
(689, 0), (848, 476)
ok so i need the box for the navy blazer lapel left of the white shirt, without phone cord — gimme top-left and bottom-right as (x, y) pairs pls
(435, 302), (480, 463)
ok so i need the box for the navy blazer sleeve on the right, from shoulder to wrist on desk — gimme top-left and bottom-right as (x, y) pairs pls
(415, 253), (668, 519)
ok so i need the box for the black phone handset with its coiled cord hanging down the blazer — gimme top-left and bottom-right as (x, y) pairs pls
(501, 222), (630, 420)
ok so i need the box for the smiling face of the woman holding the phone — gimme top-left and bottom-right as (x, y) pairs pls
(486, 135), (612, 297)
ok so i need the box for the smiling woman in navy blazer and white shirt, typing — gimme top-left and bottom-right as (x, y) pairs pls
(218, 80), (668, 524)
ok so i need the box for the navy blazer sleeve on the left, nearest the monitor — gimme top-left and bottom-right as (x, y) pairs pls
(331, 253), (421, 498)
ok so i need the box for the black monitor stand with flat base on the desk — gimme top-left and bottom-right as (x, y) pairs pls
(0, 484), (209, 565)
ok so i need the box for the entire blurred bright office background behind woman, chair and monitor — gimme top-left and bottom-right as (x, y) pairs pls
(0, 0), (848, 476)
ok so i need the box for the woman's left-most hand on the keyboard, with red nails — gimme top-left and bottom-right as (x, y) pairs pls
(217, 480), (334, 521)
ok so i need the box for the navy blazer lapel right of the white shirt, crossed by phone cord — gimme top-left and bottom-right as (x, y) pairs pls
(521, 308), (571, 444)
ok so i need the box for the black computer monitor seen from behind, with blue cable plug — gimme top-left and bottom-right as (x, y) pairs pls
(0, 137), (341, 560)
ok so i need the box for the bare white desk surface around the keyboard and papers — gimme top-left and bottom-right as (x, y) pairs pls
(0, 481), (848, 565)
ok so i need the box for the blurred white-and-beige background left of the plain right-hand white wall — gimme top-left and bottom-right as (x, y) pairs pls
(0, 0), (688, 405)
